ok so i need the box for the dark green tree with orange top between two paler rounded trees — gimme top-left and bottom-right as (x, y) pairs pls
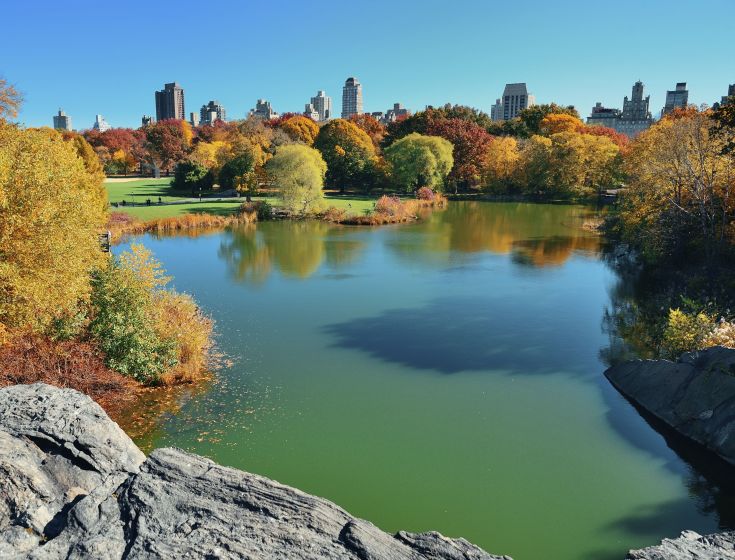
(314, 119), (376, 192)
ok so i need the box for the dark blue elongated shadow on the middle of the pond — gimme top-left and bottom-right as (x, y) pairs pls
(323, 297), (600, 375)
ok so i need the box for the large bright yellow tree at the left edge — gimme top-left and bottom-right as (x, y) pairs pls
(0, 123), (107, 331)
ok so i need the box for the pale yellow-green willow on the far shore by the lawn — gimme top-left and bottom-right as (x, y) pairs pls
(266, 144), (327, 215)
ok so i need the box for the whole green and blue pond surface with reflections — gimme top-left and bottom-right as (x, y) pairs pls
(118, 202), (735, 560)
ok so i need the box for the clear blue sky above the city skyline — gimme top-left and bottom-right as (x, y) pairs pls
(0, 0), (735, 129)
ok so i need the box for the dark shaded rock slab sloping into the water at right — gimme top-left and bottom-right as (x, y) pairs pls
(605, 347), (735, 465)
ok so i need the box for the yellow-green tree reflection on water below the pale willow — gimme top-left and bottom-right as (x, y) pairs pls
(219, 221), (364, 284)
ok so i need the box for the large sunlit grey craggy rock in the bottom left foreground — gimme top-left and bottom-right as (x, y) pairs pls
(0, 384), (508, 560)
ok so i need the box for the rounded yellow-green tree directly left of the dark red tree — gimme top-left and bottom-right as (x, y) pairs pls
(385, 132), (454, 192)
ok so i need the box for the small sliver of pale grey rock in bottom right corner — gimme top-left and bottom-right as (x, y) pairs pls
(625, 531), (735, 560)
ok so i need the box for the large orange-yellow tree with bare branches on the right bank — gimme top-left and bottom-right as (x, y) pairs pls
(620, 111), (735, 259)
